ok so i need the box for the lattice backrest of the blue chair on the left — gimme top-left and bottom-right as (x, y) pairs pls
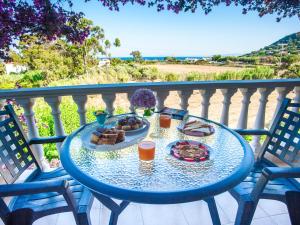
(0, 105), (38, 183)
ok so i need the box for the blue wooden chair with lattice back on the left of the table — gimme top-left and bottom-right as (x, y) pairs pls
(0, 105), (93, 225)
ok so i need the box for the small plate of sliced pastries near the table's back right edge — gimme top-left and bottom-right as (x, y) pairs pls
(177, 119), (215, 137)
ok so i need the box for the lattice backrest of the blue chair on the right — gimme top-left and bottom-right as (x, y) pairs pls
(259, 99), (300, 167)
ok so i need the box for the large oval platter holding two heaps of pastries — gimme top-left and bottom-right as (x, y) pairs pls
(81, 115), (150, 151)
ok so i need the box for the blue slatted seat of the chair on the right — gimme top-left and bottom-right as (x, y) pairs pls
(230, 163), (300, 201)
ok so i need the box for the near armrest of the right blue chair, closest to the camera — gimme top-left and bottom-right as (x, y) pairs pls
(262, 167), (300, 180)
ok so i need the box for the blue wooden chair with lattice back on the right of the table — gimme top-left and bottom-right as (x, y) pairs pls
(230, 99), (300, 225)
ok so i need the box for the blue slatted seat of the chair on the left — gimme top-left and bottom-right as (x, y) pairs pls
(12, 168), (93, 216)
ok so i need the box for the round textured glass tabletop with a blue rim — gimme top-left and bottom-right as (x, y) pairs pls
(61, 114), (253, 204)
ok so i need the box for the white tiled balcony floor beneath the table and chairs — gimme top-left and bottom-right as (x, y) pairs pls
(4, 192), (291, 225)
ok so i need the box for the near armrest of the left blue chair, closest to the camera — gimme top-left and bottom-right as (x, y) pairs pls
(0, 180), (69, 197)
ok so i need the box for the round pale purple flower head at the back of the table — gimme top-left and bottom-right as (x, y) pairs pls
(130, 88), (156, 116)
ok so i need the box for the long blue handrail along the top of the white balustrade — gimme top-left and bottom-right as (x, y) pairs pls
(0, 79), (300, 99)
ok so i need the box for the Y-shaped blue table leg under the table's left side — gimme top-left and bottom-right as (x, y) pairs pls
(93, 192), (130, 225)
